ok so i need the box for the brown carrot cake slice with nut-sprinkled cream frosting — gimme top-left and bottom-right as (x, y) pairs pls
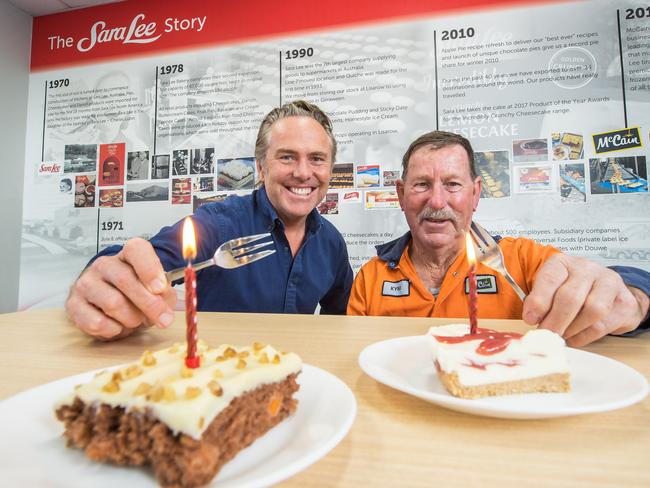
(56, 341), (302, 487)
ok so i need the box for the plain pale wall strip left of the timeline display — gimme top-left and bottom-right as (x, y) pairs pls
(0, 0), (32, 313)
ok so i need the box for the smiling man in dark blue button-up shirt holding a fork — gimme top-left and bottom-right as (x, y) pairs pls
(66, 101), (352, 339)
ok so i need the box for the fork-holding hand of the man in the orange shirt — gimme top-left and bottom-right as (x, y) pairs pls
(523, 254), (649, 346)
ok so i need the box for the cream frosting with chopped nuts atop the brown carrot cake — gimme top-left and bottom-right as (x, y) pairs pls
(59, 341), (302, 439)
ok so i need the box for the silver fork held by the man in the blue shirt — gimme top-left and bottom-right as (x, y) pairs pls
(165, 233), (275, 283)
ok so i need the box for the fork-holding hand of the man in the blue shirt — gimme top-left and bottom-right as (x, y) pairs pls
(65, 238), (176, 339)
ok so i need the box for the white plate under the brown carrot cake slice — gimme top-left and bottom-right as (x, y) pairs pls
(0, 364), (357, 488)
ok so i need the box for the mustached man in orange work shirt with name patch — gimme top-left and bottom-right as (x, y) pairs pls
(348, 131), (650, 346)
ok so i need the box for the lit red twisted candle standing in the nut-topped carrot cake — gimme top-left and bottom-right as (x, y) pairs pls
(183, 217), (201, 368)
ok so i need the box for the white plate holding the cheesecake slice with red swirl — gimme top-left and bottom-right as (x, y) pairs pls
(359, 336), (648, 419)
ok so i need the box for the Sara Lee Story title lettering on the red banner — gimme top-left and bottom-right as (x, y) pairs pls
(75, 14), (207, 52)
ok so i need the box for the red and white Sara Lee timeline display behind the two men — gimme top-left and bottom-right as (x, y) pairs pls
(19, 0), (650, 308)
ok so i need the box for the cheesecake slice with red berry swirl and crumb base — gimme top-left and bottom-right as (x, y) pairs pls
(427, 324), (571, 398)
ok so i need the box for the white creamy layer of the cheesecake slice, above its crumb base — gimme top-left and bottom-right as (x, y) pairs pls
(427, 324), (569, 386)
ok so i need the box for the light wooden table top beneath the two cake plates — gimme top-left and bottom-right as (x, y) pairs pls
(0, 309), (650, 488)
